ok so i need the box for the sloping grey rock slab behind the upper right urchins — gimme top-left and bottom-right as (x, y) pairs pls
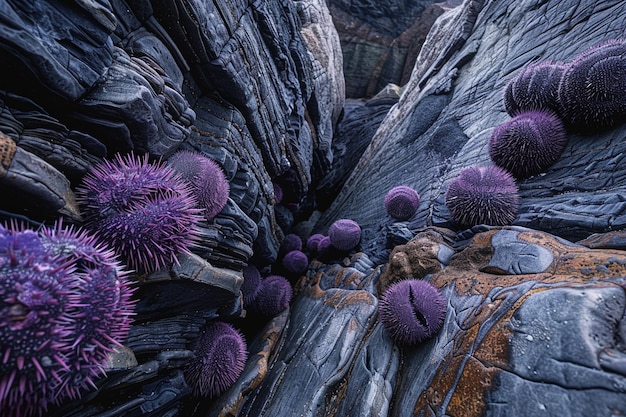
(317, 1), (626, 250)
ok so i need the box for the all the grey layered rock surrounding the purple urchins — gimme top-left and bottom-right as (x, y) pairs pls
(0, 0), (626, 417)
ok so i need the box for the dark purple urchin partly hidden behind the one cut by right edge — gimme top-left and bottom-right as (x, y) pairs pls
(504, 61), (565, 116)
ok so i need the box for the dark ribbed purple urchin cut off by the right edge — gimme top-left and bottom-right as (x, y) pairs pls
(558, 40), (626, 133)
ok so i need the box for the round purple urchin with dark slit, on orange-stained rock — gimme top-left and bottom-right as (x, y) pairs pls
(378, 279), (447, 346)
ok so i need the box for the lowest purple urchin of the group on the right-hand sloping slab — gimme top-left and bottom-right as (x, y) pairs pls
(445, 166), (519, 227)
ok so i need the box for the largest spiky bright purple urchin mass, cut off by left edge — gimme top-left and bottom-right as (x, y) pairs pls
(0, 219), (134, 417)
